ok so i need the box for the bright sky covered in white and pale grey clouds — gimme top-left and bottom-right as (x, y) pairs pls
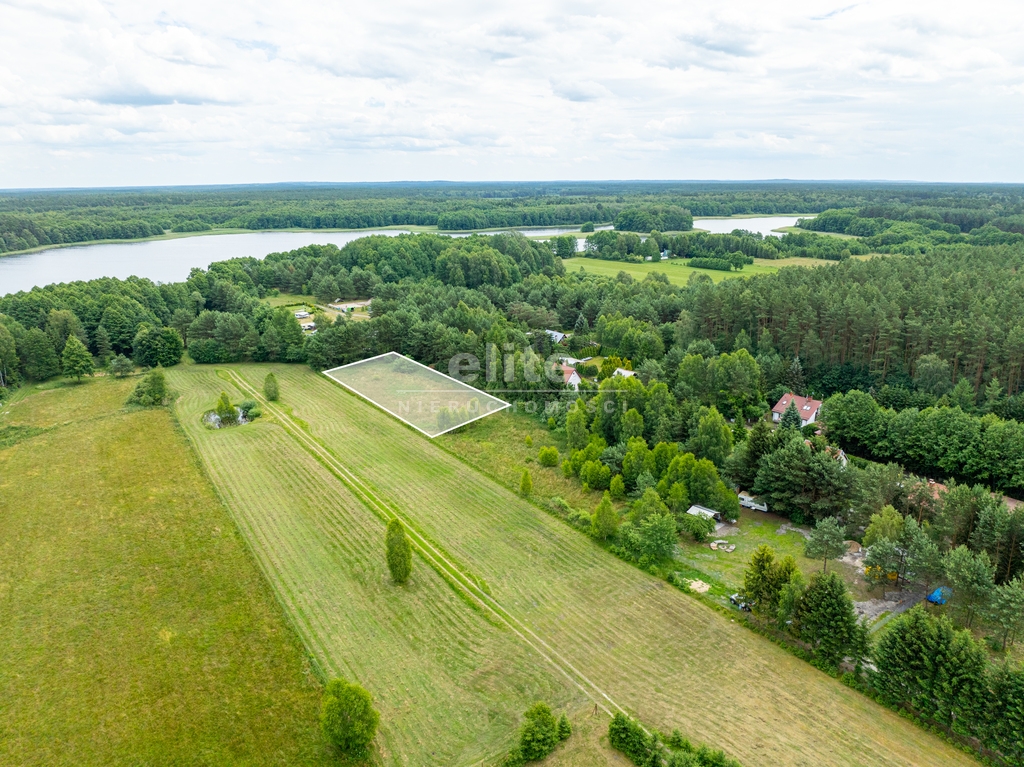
(0, 0), (1024, 188)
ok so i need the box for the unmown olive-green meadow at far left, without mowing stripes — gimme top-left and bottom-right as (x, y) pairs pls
(0, 377), (337, 767)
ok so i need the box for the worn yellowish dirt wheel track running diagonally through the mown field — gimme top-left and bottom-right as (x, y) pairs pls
(227, 370), (629, 717)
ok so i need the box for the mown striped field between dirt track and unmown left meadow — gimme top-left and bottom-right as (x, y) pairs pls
(168, 366), (587, 765)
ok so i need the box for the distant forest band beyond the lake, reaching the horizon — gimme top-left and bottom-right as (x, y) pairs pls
(0, 181), (1024, 253)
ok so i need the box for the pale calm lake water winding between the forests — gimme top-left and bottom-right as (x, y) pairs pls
(0, 216), (797, 296)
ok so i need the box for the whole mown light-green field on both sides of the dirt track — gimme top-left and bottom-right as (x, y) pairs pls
(178, 366), (973, 765)
